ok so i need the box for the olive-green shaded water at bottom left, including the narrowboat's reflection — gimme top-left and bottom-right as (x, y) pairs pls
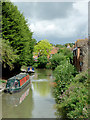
(2, 84), (34, 118)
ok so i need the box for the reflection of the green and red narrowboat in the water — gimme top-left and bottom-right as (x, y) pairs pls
(6, 85), (30, 106)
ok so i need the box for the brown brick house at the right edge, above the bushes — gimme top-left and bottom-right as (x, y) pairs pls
(73, 38), (88, 72)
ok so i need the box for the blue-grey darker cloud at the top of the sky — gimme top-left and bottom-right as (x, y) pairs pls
(15, 2), (72, 20)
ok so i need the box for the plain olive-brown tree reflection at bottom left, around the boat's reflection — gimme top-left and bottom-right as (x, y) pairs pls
(2, 85), (34, 118)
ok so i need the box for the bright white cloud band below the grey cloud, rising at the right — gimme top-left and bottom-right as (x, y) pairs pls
(30, 2), (88, 38)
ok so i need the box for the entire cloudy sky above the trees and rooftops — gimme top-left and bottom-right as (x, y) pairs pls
(11, 0), (88, 44)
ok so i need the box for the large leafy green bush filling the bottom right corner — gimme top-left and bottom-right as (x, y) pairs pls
(54, 71), (89, 118)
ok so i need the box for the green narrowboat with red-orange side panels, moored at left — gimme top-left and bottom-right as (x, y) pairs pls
(4, 73), (30, 93)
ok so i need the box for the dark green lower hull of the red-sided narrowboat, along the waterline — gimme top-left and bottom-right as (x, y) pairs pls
(4, 79), (30, 94)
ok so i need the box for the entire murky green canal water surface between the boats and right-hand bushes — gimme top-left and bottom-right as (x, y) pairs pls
(2, 69), (56, 118)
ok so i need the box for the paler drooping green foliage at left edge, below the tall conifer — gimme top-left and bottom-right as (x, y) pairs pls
(0, 40), (18, 70)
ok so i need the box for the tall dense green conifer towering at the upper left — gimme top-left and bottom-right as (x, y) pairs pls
(2, 2), (35, 65)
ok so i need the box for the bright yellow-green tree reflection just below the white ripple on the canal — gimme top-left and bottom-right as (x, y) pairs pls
(32, 81), (50, 96)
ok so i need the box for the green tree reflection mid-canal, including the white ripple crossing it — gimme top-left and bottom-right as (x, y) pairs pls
(31, 69), (52, 96)
